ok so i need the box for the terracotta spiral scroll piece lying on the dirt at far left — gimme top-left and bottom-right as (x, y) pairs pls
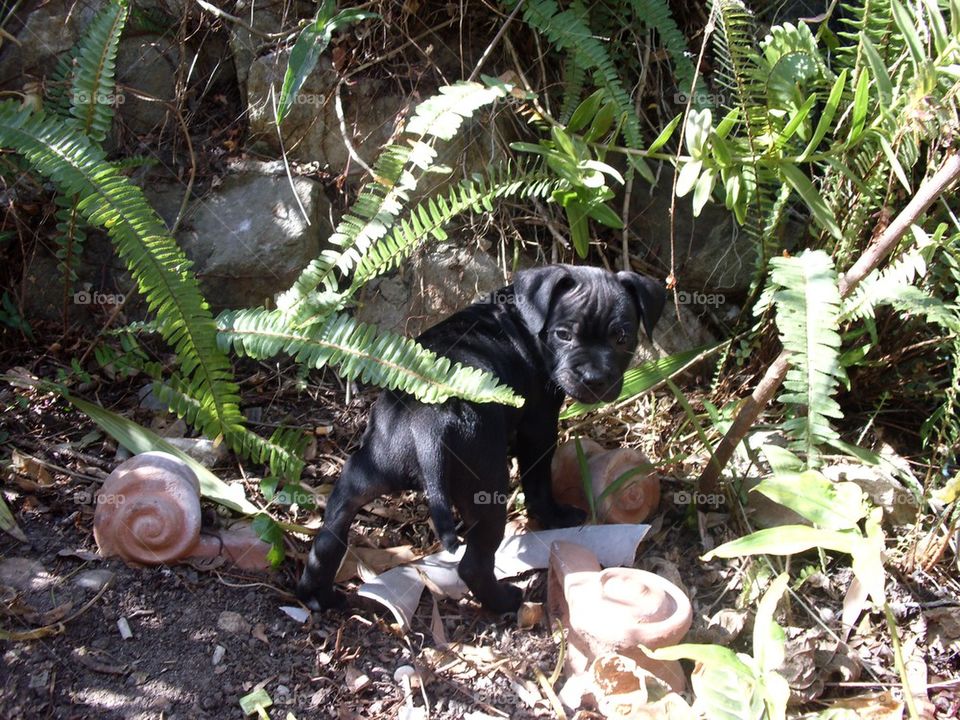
(93, 452), (270, 570)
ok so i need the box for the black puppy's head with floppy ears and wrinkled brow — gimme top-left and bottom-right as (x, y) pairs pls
(513, 265), (666, 403)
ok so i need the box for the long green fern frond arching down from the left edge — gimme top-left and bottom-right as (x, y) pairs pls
(0, 101), (243, 444)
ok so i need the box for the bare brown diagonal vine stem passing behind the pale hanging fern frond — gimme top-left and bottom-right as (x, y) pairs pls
(697, 153), (960, 494)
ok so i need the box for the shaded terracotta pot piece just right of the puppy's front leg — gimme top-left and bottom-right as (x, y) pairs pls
(550, 438), (660, 523)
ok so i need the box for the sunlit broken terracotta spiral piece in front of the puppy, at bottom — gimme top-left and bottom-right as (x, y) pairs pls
(547, 542), (693, 692)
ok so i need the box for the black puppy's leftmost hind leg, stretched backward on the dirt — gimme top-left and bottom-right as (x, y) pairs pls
(297, 447), (391, 610)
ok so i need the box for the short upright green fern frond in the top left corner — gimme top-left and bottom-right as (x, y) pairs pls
(70, 0), (127, 143)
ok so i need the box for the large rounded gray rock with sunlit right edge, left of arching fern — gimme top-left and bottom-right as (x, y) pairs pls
(172, 173), (330, 309)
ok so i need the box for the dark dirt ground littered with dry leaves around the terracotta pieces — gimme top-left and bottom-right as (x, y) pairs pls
(0, 356), (960, 720)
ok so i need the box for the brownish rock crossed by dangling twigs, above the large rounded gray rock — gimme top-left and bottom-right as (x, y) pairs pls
(247, 50), (408, 175)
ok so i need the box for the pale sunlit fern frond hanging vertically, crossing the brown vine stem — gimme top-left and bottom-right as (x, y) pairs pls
(770, 250), (843, 467)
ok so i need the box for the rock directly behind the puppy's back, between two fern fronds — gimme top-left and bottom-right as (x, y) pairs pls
(357, 244), (508, 337)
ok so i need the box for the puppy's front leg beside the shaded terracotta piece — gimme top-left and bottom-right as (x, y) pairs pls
(515, 417), (587, 528)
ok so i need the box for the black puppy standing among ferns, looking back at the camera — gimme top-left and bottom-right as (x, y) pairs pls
(297, 265), (666, 612)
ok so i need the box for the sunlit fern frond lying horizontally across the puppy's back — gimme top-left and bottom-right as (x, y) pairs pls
(220, 308), (523, 406)
